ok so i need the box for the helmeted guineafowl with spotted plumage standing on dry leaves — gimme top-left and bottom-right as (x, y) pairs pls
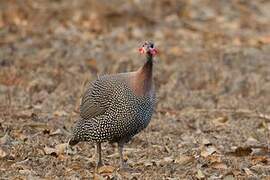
(68, 41), (158, 169)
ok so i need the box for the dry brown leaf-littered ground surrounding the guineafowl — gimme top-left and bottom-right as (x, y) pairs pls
(0, 0), (270, 180)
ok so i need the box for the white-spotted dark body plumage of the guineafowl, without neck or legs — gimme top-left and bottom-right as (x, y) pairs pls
(69, 73), (155, 142)
